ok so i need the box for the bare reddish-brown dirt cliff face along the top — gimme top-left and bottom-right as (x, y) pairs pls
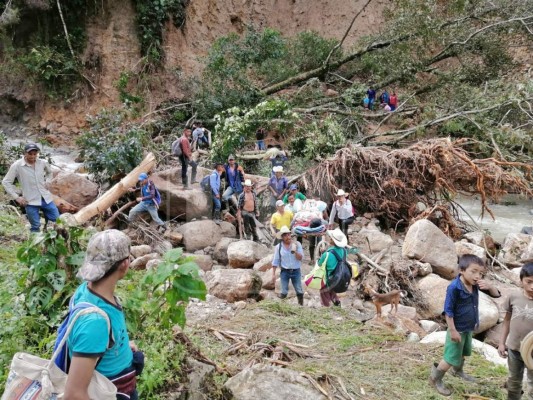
(15, 0), (389, 134)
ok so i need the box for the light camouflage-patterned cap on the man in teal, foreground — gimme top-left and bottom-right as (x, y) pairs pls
(78, 229), (131, 282)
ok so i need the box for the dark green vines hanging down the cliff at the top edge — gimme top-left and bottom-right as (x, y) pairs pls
(134, 0), (189, 65)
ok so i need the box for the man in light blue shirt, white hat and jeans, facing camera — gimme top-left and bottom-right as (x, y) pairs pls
(272, 226), (304, 306)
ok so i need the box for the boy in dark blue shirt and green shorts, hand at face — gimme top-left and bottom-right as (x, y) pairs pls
(429, 254), (500, 396)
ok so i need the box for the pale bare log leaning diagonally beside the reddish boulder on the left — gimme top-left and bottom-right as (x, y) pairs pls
(74, 153), (155, 225)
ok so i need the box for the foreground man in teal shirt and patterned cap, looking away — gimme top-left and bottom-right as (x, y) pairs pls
(63, 229), (144, 400)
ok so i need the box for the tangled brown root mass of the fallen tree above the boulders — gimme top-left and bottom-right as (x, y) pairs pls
(302, 139), (533, 230)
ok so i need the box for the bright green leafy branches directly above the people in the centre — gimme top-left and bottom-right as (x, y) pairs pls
(211, 99), (298, 160)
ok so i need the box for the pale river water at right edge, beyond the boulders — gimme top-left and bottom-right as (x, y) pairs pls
(457, 195), (533, 243)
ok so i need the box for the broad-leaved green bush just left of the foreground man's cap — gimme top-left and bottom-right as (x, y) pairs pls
(17, 227), (88, 326)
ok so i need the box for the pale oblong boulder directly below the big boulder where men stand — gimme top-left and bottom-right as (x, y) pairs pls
(177, 220), (237, 251)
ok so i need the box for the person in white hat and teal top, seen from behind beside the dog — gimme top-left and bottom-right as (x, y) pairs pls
(318, 228), (348, 307)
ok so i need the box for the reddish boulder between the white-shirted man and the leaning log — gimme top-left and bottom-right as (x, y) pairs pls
(47, 172), (98, 208)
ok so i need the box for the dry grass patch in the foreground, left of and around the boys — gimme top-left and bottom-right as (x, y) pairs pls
(187, 300), (506, 400)
